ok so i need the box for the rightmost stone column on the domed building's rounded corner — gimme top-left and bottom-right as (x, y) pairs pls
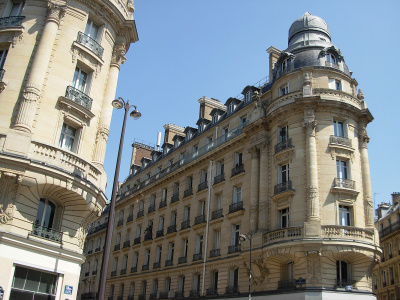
(359, 124), (374, 227)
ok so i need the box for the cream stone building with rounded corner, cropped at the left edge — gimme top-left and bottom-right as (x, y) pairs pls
(0, 0), (137, 299)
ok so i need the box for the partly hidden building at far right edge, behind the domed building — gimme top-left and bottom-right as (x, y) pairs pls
(372, 193), (400, 300)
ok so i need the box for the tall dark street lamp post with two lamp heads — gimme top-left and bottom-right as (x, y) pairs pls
(97, 97), (142, 300)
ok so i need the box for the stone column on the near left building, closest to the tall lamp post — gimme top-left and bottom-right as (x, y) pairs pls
(92, 44), (126, 167)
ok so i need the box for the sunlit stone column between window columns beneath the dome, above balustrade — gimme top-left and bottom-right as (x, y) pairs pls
(303, 108), (320, 221)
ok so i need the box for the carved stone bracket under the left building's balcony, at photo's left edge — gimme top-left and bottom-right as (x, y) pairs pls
(0, 172), (22, 226)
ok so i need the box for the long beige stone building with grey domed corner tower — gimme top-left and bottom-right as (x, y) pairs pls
(102, 13), (381, 300)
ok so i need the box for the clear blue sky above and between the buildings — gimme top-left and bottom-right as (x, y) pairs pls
(105, 0), (400, 211)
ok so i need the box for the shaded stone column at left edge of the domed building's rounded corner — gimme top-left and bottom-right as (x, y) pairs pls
(258, 142), (270, 230)
